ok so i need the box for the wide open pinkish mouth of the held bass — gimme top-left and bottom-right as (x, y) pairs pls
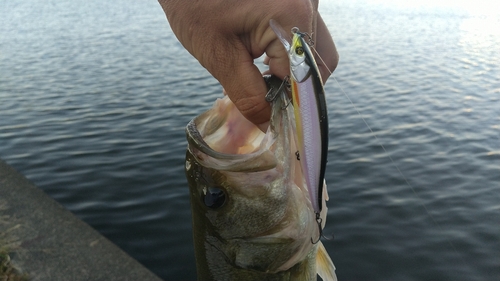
(186, 94), (276, 172)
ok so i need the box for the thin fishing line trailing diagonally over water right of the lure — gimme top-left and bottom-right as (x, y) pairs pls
(311, 46), (466, 265)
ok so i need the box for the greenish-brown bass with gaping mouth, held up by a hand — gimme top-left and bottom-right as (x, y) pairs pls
(185, 76), (336, 281)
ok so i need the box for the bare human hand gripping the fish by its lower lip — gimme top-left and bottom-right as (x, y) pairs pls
(159, 0), (338, 125)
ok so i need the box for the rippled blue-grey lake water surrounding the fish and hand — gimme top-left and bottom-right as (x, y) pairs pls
(0, 0), (500, 280)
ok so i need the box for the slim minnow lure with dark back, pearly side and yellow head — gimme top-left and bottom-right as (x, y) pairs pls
(269, 20), (328, 223)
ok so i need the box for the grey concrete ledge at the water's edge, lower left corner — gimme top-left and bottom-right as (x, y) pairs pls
(0, 160), (161, 281)
